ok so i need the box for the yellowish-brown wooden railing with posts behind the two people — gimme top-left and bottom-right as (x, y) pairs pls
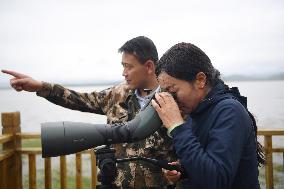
(0, 112), (284, 189)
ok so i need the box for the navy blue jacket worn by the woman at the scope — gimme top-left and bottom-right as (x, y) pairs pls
(171, 83), (260, 189)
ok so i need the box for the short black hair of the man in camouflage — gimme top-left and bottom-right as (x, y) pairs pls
(118, 36), (158, 65)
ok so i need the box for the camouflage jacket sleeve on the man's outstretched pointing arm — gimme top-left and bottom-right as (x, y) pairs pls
(36, 82), (112, 115)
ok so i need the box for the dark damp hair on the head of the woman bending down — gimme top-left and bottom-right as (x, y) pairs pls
(156, 43), (220, 86)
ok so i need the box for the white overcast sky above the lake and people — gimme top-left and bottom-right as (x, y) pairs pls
(0, 0), (284, 85)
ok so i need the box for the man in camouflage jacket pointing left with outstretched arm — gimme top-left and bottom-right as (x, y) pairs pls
(2, 36), (176, 188)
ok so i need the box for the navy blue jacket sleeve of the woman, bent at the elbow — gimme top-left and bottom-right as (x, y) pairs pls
(171, 99), (252, 189)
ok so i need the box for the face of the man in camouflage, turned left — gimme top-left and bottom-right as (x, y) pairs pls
(121, 52), (149, 89)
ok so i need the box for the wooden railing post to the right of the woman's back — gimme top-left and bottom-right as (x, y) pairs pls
(264, 135), (273, 189)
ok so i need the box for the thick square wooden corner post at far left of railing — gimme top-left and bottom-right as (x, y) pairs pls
(1, 112), (23, 189)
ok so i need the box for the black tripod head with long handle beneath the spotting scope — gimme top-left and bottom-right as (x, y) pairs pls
(95, 145), (185, 189)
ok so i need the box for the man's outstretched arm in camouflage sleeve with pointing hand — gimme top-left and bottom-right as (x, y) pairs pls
(1, 70), (108, 114)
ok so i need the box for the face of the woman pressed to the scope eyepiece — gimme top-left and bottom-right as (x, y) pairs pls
(158, 72), (202, 114)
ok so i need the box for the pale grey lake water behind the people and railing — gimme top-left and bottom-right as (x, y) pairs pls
(0, 81), (284, 160)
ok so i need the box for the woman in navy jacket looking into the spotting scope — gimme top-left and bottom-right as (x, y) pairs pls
(152, 43), (264, 189)
